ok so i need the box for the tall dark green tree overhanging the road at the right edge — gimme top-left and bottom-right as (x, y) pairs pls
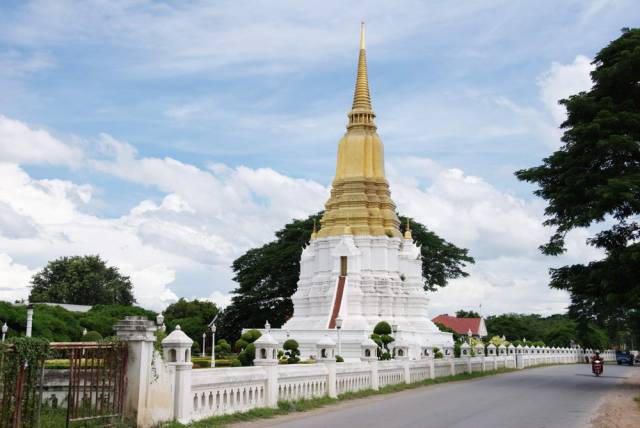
(516, 29), (640, 346)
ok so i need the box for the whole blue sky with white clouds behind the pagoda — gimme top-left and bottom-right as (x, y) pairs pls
(0, 0), (640, 313)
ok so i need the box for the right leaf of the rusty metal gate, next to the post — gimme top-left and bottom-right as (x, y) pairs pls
(52, 342), (127, 427)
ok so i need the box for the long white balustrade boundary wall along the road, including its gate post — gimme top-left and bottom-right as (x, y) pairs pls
(114, 316), (615, 427)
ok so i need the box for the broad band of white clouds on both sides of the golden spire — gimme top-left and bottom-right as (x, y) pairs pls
(0, 113), (599, 313)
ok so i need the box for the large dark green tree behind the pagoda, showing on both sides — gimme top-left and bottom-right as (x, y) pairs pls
(219, 212), (474, 340)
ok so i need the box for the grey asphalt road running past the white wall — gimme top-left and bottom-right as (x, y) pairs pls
(248, 364), (640, 428)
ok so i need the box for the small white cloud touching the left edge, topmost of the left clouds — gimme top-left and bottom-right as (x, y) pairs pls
(0, 114), (82, 165)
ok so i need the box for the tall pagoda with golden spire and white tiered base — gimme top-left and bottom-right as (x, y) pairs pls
(262, 24), (453, 360)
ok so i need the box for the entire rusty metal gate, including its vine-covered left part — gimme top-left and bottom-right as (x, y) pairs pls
(0, 341), (127, 428)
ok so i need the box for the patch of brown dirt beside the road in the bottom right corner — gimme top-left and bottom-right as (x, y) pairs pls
(591, 369), (640, 428)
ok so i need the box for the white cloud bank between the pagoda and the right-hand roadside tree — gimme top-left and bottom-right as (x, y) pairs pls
(387, 157), (602, 316)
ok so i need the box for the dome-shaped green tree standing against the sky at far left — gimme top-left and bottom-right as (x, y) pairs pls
(29, 255), (136, 305)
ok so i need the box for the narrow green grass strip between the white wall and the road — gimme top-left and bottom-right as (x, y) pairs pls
(161, 369), (516, 428)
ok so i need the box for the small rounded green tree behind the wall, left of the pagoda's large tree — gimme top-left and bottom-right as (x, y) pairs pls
(163, 298), (218, 355)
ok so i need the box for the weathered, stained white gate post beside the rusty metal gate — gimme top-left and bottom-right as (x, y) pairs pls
(113, 316), (157, 423)
